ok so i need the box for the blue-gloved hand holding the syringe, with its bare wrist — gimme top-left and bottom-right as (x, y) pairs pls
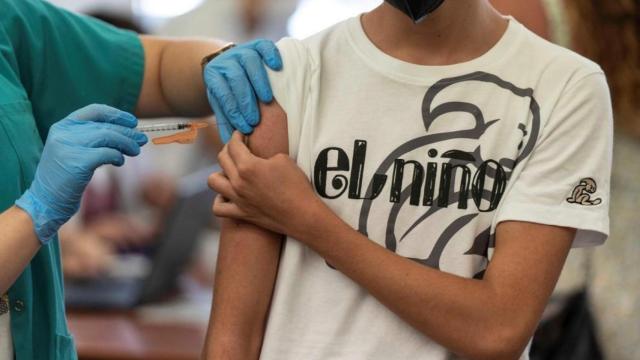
(0, 105), (147, 294)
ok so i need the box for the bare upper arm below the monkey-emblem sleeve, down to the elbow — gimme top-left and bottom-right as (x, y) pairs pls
(483, 221), (576, 348)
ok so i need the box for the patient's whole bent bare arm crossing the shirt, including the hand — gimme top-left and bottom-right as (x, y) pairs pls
(209, 133), (575, 359)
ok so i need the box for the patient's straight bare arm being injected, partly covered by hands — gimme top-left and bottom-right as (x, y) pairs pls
(203, 103), (288, 360)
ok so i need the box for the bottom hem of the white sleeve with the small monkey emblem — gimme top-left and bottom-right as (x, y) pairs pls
(495, 205), (609, 248)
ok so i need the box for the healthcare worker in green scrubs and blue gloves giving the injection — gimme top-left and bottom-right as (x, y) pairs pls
(0, 0), (282, 360)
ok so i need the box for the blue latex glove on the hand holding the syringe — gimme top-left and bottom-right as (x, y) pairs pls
(16, 105), (148, 245)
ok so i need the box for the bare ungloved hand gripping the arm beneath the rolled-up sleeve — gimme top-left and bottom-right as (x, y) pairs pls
(209, 132), (324, 237)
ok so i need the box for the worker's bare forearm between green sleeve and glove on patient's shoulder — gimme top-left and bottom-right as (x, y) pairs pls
(136, 36), (224, 117)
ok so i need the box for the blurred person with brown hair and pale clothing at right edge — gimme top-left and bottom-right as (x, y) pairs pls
(563, 0), (640, 360)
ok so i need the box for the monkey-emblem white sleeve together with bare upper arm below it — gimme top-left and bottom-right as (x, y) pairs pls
(484, 73), (612, 348)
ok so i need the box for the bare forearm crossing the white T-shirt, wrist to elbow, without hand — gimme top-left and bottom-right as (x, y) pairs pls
(293, 213), (556, 359)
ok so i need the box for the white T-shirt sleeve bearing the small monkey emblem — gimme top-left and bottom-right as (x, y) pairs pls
(494, 73), (613, 247)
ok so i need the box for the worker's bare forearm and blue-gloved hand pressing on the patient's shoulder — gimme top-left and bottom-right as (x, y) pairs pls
(135, 36), (282, 142)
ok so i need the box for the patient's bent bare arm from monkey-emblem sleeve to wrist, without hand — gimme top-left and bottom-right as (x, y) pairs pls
(294, 214), (575, 360)
